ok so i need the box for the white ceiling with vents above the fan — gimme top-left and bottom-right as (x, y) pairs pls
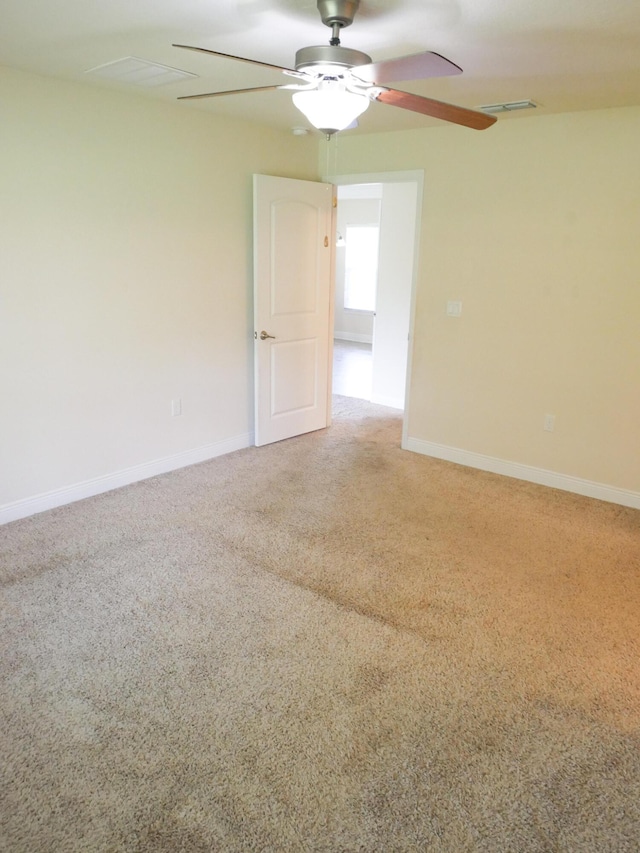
(0, 0), (640, 133)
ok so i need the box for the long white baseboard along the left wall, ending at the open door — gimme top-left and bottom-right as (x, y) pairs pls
(0, 434), (253, 525)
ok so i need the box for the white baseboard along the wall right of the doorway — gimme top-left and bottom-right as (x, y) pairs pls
(403, 438), (640, 509)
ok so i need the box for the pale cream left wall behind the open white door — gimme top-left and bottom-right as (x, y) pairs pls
(0, 69), (317, 508)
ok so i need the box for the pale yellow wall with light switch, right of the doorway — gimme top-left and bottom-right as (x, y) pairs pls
(328, 108), (640, 495)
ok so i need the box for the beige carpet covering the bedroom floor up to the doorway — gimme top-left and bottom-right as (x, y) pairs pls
(0, 398), (640, 853)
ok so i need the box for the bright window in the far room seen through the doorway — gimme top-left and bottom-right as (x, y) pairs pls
(344, 225), (380, 311)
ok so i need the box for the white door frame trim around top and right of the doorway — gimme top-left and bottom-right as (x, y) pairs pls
(320, 169), (424, 449)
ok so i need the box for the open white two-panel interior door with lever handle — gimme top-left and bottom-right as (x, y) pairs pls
(253, 175), (335, 446)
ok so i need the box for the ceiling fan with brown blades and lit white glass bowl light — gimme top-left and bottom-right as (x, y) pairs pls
(173, 0), (496, 136)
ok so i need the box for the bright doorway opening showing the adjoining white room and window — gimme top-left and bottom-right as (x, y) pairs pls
(330, 172), (423, 410)
